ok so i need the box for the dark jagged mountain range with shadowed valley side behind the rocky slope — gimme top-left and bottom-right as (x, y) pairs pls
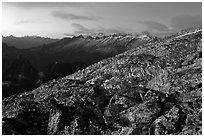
(2, 34), (158, 98)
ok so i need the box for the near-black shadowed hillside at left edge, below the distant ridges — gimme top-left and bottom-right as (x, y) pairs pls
(2, 43), (41, 98)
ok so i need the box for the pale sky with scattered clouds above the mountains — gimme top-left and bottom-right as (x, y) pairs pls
(2, 2), (202, 38)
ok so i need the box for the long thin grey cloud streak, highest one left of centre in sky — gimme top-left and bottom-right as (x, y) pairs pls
(52, 11), (101, 21)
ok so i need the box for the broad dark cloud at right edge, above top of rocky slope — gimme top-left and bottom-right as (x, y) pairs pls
(171, 15), (202, 29)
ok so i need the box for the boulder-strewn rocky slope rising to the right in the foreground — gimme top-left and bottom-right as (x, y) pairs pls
(2, 30), (202, 135)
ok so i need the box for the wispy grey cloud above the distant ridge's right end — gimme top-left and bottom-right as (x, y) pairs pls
(139, 21), (169, 31)
